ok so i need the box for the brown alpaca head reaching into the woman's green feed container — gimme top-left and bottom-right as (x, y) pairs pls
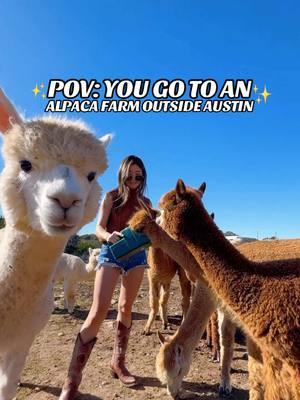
(128, 207), (159, 244)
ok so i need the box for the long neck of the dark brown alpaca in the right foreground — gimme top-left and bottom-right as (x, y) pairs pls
(181, 203), (263, 322)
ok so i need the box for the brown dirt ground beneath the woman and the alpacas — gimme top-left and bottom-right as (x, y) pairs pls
(17, 274), (248, 400)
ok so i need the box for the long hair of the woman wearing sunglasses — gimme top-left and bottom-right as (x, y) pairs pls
(115, 155), (147, 208)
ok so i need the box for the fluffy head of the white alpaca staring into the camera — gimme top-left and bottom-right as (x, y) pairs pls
(0, 90), (110, 237)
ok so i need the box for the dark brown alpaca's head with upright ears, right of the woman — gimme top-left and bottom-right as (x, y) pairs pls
(159, 179), (206, 240)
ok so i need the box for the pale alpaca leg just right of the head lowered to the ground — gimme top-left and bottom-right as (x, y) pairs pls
(218, 309), (236, 396)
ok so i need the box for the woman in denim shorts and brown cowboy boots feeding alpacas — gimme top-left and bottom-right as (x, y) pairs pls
(59, 155), (151, 400)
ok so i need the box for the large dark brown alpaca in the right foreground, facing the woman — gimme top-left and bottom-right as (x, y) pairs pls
(160, 180), (300, 400)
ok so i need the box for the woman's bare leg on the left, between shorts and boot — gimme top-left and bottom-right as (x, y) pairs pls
(80, 267), (120, 343)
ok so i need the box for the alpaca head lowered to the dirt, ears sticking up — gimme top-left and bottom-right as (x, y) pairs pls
(156, 332), (190, 399)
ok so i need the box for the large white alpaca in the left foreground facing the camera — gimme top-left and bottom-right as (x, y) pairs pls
(0, 90), (110, 400)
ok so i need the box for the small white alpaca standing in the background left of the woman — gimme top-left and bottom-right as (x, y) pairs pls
(54, 247), (100, 314)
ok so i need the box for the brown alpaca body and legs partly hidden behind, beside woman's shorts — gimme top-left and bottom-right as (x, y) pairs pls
(143, 247), (192, 335)
